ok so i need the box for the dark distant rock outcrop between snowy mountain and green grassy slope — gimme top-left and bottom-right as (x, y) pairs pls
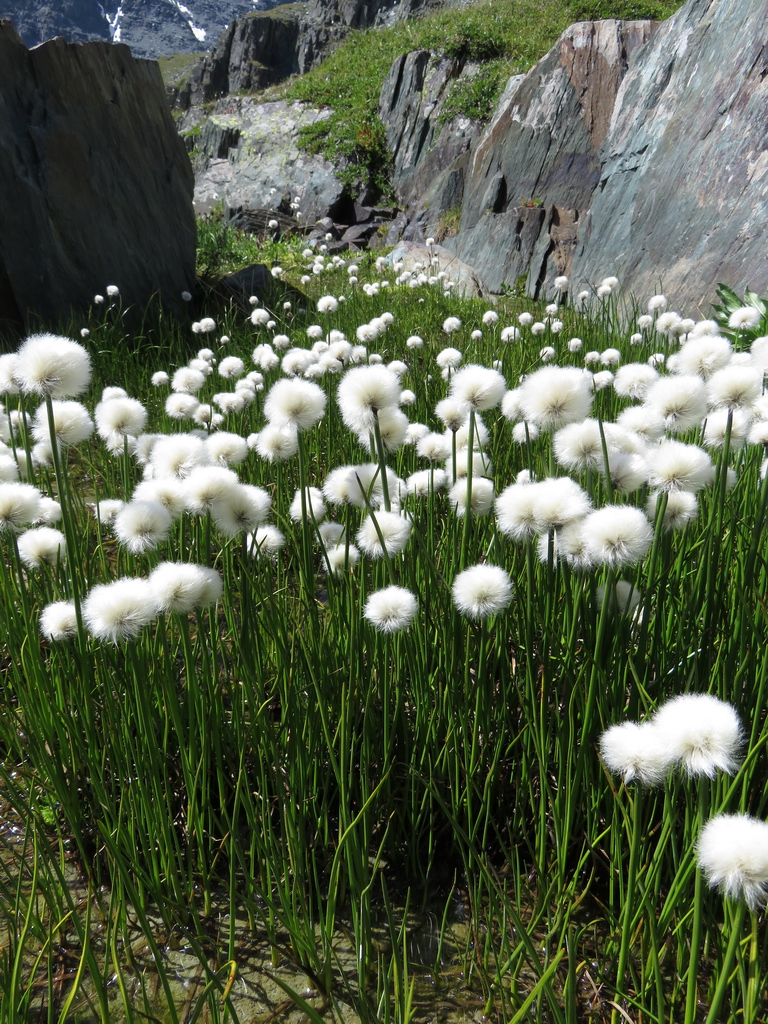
(171, 0), (456, 110)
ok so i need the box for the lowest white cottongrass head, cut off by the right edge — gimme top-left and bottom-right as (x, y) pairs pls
(696, 814), (768, 911)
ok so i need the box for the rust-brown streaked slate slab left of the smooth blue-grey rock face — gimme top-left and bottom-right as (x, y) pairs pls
(445, 20), (654, 297)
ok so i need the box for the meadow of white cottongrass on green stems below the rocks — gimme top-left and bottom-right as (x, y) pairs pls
(0, 241), (768, 1024)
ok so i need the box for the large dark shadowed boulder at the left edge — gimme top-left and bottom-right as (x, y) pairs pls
(0, 22), (196, 323)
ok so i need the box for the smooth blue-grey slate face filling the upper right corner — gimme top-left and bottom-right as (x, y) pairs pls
(573, 0), (768, 309)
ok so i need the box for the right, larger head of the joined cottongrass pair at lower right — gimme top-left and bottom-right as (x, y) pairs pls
(653, 693), (742, 778)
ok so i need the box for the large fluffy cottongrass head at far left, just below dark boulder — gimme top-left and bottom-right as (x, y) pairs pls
(13, 334), (91, 398)
